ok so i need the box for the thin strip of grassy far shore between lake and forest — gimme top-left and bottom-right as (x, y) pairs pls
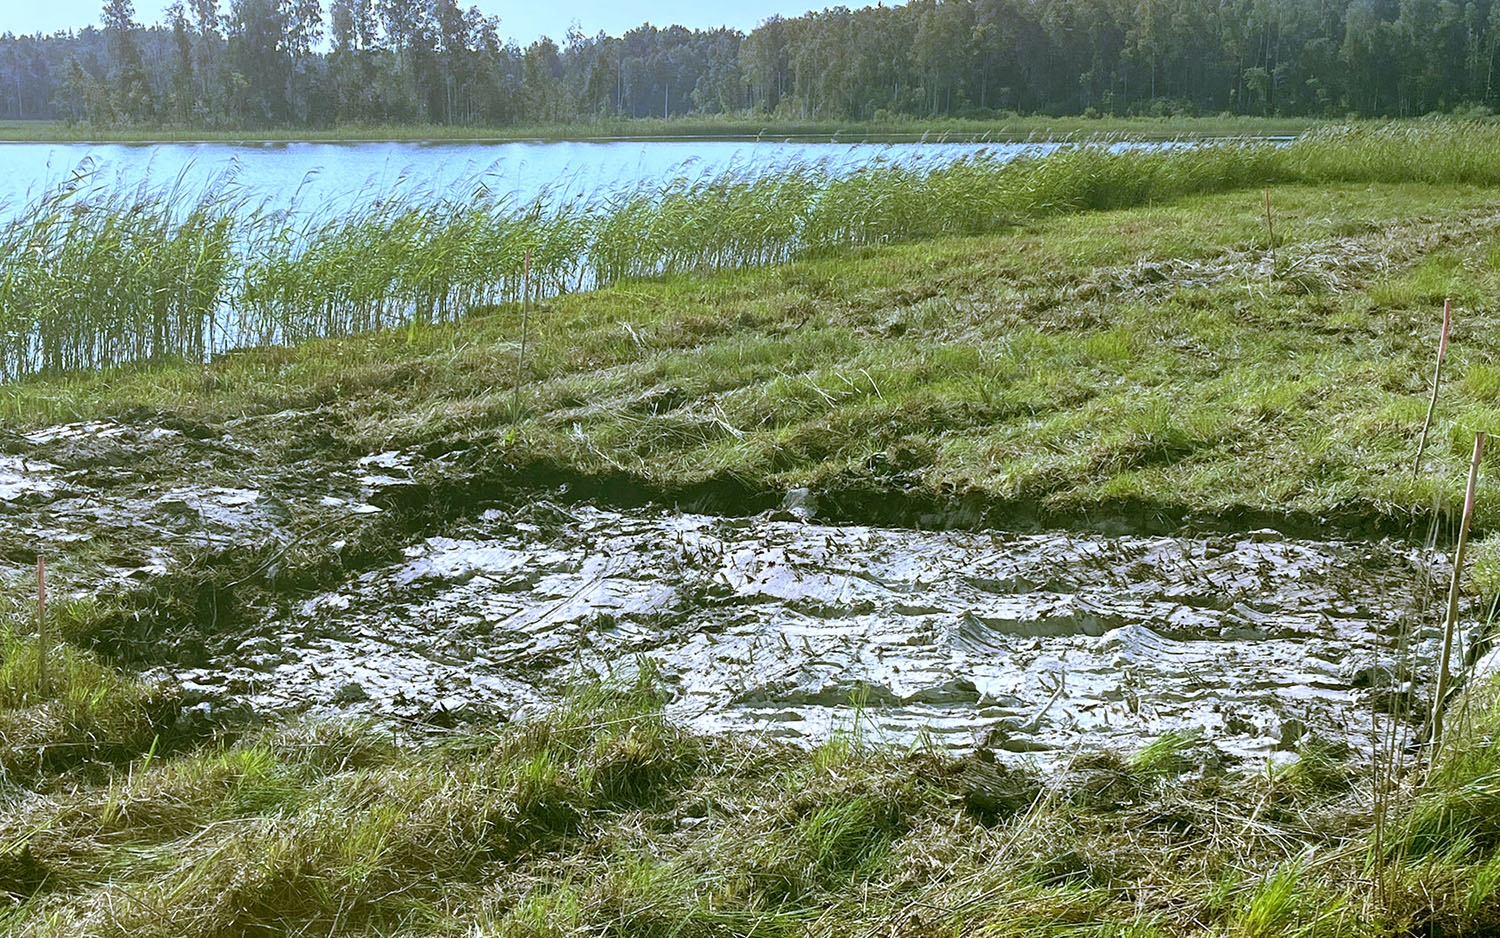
(0, 116), (1328, 144)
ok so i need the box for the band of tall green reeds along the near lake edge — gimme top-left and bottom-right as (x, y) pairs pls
(0, 122), (1500, 380)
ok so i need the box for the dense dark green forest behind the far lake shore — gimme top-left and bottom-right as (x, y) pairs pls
(0, 0), (1500, 129)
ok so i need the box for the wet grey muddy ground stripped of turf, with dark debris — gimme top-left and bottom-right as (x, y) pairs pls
(0, 414), (1478, 761)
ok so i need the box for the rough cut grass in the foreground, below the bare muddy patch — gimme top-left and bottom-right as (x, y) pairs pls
(0, 621), (1500, 938)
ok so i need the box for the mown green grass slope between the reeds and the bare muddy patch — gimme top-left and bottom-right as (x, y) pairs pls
(0, 171), (1500, 528)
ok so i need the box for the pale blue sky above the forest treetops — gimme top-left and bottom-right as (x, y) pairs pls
(0, 0), (822, 45)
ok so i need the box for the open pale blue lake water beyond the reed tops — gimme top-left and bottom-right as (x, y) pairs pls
(0, 140), (1062, 215)
